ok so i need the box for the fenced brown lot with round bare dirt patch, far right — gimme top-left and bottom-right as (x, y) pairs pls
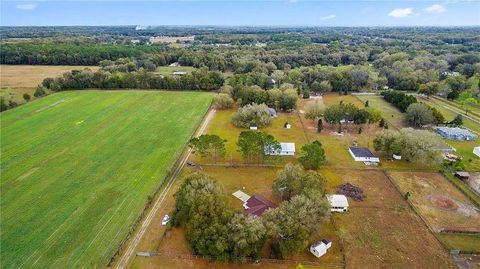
(390, 172), (480, 232)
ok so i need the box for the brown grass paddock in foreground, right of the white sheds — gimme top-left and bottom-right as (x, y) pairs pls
(328, 169), (453, 268)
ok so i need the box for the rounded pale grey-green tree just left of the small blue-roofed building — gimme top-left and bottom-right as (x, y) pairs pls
(232, 103), (272, 128)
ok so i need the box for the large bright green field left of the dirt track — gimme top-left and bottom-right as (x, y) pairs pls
(0, 91), (212, 268)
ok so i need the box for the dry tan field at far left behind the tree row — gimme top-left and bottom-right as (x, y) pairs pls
(0, 65), (98, 102)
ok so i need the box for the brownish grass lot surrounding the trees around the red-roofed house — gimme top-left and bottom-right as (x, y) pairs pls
(132, 166), (342, 268)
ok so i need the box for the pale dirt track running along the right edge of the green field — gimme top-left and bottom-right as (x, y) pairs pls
(115, 109), (215, 269)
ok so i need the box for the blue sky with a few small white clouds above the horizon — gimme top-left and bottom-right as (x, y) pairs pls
(0, 0), (480, 26)
